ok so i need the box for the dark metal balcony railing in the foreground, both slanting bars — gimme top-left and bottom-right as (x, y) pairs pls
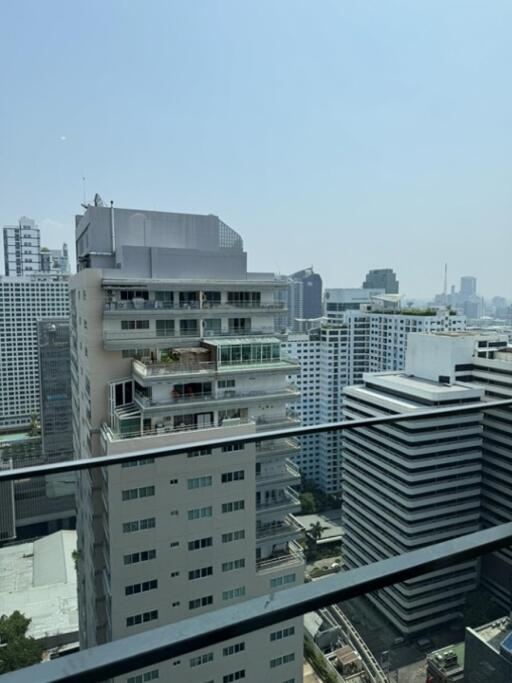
(0, 399), (512, 683)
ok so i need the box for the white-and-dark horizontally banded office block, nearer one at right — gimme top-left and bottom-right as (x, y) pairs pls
(342, 372), (483, 635)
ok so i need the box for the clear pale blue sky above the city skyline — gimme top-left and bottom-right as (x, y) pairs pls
(0, 0), (512, 298)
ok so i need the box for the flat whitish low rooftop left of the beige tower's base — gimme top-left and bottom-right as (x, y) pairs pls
(0, 531), (78, 639)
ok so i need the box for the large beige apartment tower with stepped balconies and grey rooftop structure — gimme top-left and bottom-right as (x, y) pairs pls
(71, 207), (304, 683)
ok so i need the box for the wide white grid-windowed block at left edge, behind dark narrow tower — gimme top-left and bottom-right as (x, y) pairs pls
(0, 274), (69, 430)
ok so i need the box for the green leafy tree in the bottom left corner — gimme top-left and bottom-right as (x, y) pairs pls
(0, 610), (43, 674)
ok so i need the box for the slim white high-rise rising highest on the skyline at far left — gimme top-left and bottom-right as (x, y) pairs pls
(4, 216), (41, 277)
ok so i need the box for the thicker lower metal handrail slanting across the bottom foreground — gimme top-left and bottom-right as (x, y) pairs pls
(2, 522), (512, 683)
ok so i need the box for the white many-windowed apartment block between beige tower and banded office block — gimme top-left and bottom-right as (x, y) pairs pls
(283, 306), (465, 495)
